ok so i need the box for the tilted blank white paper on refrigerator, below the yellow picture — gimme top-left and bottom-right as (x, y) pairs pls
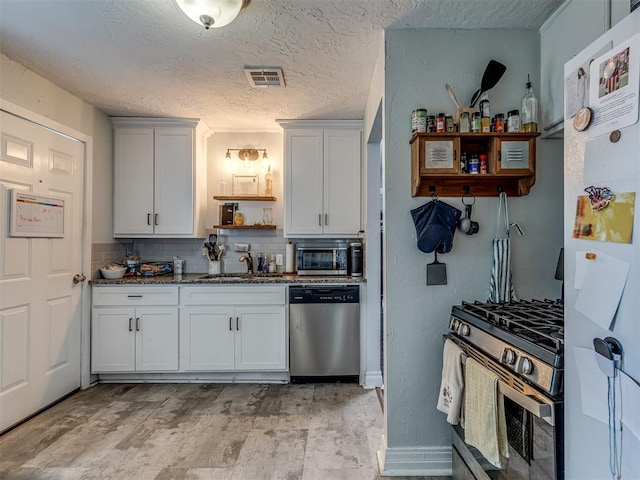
(575, 250), (630, 330)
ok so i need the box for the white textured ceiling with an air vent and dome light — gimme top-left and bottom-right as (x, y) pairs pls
(0, 0), (561, 131)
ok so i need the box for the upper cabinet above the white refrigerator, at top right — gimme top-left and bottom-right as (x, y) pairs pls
(540, 0), (611, 137)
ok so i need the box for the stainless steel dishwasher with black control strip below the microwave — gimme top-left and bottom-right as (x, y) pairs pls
(289, 285), (360, 383)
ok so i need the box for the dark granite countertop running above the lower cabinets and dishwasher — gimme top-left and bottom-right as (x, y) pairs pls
(90, 273), (366, 285)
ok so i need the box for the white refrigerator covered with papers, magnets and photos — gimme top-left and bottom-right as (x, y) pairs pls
(564, 8), (640, 480)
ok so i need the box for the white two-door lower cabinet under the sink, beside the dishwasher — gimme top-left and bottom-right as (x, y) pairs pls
(180, 285), (288, 372)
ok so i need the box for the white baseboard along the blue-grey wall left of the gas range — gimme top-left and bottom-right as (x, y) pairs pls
(377, 435), (451, 477)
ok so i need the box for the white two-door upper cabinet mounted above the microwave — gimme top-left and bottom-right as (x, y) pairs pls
(279, 120), (362, 238)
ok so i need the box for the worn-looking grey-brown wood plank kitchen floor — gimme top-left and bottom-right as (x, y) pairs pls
(0, 384), (450, 480)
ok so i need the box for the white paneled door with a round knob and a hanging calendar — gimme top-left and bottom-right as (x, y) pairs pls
(0, 111), (85, 431)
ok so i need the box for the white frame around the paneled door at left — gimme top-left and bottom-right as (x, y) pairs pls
(0, 98), (93, 389)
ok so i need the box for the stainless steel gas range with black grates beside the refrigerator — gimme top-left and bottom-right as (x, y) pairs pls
(448, 300), (564, 480)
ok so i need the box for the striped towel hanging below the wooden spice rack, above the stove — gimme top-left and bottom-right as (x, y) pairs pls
(489, 192), (518, 303)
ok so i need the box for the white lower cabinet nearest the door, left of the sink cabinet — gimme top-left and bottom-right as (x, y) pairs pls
(91, 286), (178, 373)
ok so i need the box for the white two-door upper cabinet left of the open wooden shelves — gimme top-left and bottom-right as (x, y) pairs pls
(112, 117), (206, 237)
